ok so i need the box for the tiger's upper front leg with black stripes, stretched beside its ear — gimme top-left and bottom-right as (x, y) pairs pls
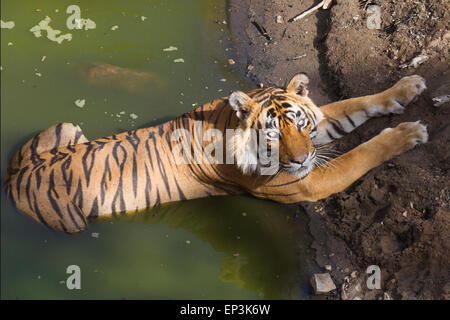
(313, 75), (426, 145)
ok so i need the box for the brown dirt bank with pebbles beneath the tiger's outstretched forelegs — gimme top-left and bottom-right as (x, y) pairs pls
(230, 0), (450, 299)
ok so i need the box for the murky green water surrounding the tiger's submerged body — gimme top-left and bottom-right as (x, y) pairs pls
(1, 0), (311, 299)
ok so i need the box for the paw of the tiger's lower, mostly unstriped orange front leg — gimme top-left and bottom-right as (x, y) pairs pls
(377, 121), (428, 157)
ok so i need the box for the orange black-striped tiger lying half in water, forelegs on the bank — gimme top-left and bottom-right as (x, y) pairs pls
(4, 73), (428, 234)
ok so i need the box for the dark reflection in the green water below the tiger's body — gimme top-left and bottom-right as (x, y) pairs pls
(102, 197), (310, 299)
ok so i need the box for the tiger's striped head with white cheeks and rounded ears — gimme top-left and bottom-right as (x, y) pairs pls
(229, 74), (323, 178)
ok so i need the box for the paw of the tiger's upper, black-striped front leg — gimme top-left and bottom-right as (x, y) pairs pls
(382, 75), (427, 114)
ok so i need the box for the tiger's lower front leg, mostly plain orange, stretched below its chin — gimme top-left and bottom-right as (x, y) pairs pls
(284, 121), (428, 203)
